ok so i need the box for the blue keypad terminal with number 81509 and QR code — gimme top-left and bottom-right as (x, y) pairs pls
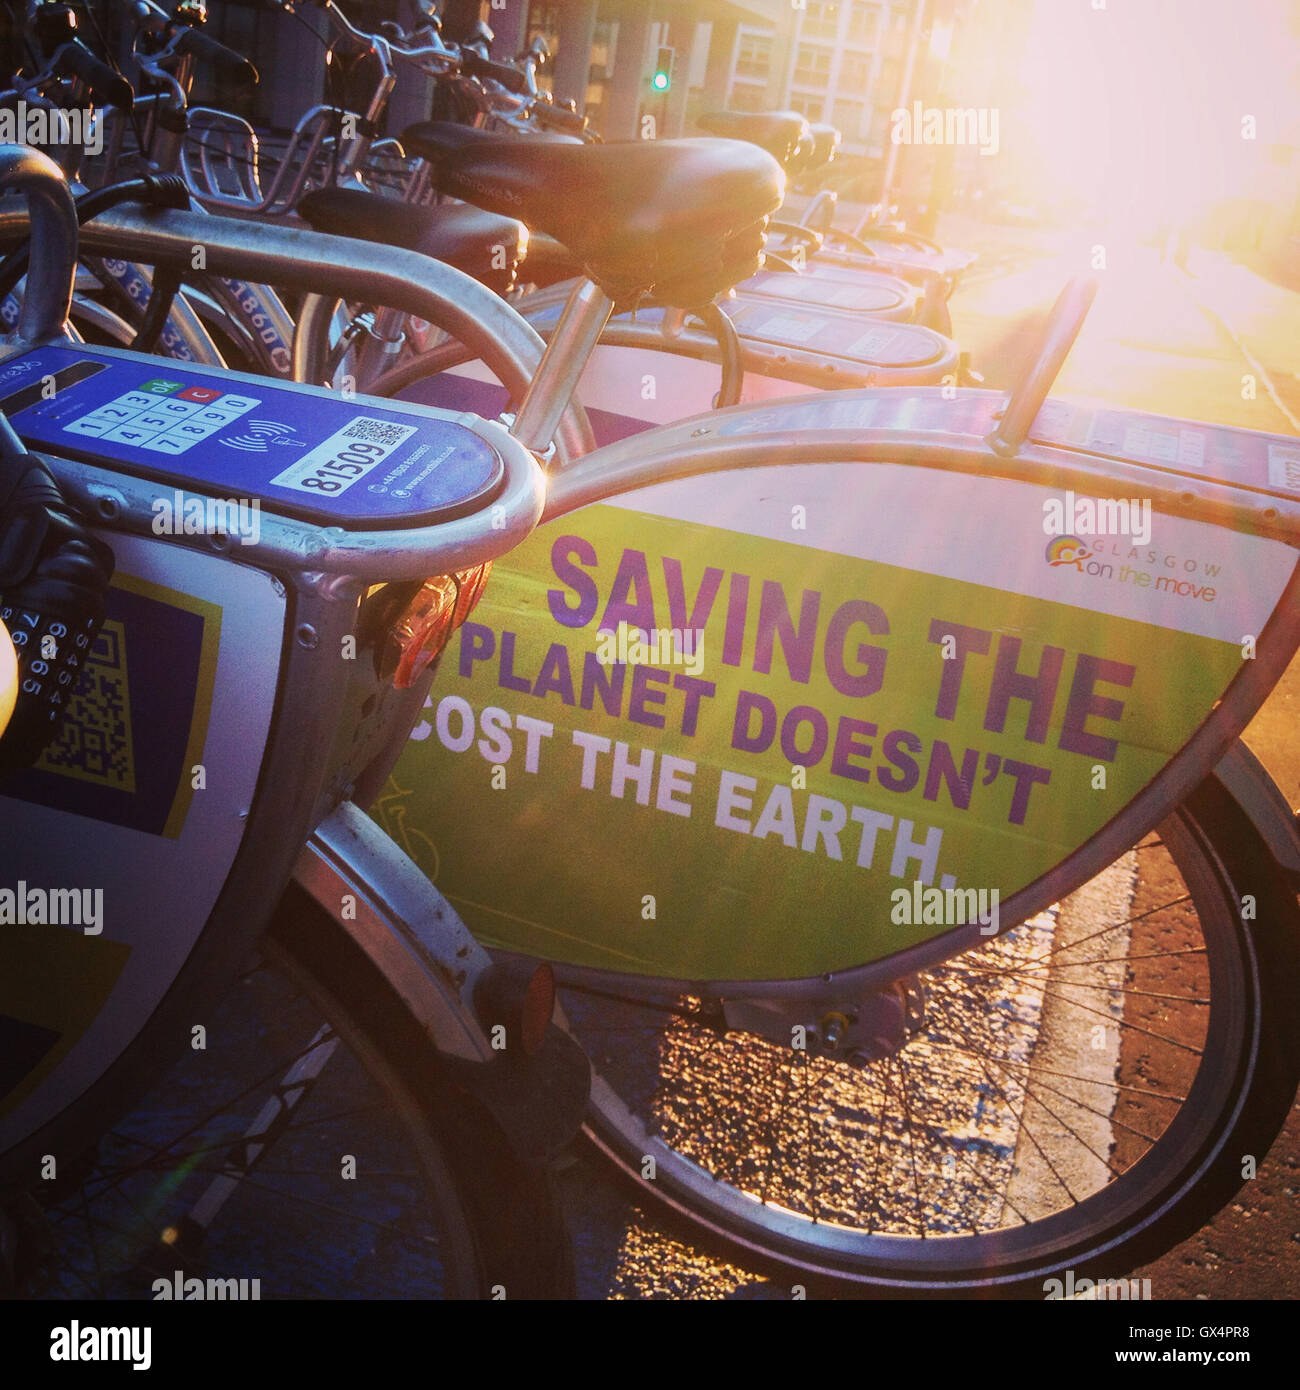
(0, 343), (505, 530)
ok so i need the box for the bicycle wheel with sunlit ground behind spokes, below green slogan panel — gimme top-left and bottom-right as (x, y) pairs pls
(562, 761), (1297, 1298)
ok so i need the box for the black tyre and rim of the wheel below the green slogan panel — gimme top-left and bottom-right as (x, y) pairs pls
(562, 756), (1300, 1298)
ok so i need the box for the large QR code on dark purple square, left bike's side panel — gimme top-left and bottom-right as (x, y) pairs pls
(36, 621), (135, 792)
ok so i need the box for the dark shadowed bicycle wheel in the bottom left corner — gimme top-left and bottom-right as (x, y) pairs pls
(10, 890), (571, 1298)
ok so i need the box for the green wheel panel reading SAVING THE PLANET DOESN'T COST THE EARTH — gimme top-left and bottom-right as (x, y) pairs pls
(375, 470), (1290, 980)
